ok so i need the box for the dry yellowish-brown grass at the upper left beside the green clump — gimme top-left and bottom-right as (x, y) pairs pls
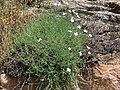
(0, 0), (29, 59)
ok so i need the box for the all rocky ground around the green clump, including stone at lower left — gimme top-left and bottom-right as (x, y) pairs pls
(0, 0), (120, 90)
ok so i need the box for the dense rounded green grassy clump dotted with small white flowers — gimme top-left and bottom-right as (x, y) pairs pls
(11, 14), (83, 90)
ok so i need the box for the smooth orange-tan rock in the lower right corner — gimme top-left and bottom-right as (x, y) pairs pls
(92, 58), (120, 90)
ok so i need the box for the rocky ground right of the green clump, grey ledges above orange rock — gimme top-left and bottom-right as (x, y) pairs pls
(66, 0), (120, 90)
